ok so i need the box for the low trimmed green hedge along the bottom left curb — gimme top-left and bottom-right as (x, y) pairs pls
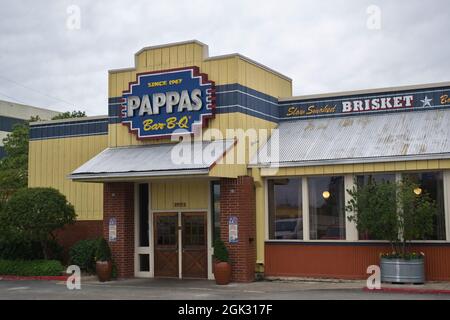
(0, 260), (64, 276)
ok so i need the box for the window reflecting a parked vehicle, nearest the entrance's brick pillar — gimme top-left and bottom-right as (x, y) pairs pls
(268, 179), (303, 239)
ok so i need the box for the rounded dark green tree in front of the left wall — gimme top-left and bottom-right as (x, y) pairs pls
(0, 188), (76, 259)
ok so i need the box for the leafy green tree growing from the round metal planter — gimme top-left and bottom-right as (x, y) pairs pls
(345, 179), (437, 258)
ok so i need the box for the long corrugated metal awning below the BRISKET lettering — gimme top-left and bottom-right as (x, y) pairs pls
(251, 110), (450, 167)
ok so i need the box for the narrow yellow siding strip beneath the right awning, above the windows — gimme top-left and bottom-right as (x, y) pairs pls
(261, 159), (450, 177)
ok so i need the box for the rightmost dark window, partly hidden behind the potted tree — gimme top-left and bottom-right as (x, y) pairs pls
(404, 172), (446, 240)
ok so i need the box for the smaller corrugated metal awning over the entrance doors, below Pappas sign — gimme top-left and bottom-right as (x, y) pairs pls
(69, 140), (234, 181)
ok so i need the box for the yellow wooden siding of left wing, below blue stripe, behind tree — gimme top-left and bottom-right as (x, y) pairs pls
(28, 135), (108, 220)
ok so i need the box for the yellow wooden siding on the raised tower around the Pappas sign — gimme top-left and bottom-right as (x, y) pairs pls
(108, 42), (292, 147)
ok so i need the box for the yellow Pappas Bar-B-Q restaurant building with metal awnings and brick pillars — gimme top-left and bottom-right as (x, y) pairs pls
(29, 41), (450, 281)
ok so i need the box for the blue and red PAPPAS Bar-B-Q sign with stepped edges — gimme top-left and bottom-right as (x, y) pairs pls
(121, 67), (215, 138)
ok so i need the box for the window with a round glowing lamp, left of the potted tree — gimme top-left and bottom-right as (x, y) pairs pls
(308, 176), (345, 240)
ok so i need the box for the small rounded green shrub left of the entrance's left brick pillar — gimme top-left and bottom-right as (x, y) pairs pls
(69, 239), (99, 273)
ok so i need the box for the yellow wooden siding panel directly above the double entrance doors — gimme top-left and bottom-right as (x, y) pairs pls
(150, 179), (210, 210)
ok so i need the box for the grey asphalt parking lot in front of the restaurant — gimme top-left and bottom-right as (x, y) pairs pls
(0, 279), (450, 300)
